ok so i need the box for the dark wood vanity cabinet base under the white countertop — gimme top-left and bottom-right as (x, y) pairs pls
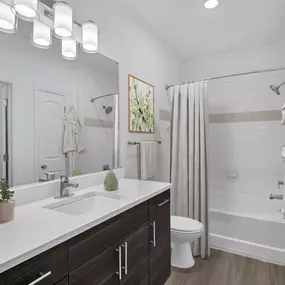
(0, 191), (171, 285)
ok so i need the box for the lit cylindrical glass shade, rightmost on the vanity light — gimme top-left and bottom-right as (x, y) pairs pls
(81, 21), (98, 53)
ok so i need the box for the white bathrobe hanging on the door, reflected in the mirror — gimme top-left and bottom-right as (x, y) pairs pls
(63, 107), (85, 176)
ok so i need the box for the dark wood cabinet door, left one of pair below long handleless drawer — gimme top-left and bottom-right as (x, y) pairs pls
(69, 241), (122, 285)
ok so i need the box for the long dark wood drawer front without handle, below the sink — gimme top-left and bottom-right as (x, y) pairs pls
(69, 202), (149, 272)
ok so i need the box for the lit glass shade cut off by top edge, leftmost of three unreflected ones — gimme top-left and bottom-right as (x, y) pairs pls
(12, 0), (39, 21)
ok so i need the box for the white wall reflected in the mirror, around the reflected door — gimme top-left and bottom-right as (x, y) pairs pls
(0, 33), (118, 186)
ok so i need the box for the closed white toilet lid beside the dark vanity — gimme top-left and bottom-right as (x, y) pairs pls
(171, 216), (204, 232)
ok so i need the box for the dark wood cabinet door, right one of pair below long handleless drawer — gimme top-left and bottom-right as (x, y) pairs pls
(122, 223), (149, 285)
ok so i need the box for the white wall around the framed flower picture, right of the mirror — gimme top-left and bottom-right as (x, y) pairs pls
(69, 0), (181, 180)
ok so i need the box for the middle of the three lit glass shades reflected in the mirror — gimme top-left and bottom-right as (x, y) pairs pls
(31, 21), (52, 49)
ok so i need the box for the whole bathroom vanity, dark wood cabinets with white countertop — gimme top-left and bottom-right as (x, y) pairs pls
(0, 179), (171, 285)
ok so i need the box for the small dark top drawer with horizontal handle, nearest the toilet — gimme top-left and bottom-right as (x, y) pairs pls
(149, 190), (170, 221)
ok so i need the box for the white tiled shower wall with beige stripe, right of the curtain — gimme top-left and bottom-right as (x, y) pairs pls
(208, 69), (285, 207)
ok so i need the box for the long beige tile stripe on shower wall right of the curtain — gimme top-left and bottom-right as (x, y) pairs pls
(209, 110), (281, 124)
